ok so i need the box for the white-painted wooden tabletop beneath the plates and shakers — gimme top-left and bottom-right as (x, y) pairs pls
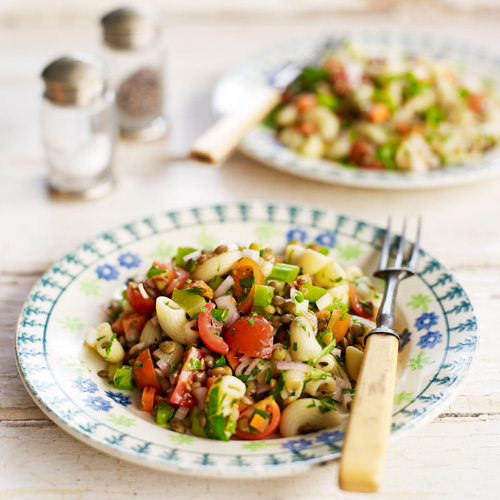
(0, 7), (500, 500)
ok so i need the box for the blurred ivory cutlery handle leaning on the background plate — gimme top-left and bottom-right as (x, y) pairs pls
(190, 85), (281, 164)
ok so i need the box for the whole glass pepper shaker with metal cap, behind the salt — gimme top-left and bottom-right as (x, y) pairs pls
(101, 7), (168, 141)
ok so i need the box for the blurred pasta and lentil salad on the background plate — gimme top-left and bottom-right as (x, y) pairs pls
(265, 42), (500, 173)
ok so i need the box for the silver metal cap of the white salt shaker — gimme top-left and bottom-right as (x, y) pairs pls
(42, 52), (106, 107)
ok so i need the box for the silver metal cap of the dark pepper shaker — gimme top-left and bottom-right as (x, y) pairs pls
(101, 7), (161, 50)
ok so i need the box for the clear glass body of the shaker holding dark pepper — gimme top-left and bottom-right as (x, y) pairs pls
(105, 37), (167, 140)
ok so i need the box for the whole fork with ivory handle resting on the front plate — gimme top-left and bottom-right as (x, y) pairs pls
(339, 219), (421, 492)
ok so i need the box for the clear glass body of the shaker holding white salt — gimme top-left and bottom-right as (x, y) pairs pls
(42, 90), (117, 197)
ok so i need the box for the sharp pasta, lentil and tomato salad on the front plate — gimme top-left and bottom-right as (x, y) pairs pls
(85, 242), (381, 441)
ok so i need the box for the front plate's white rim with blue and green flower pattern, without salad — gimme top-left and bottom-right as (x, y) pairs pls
(16, 203), (477, 477)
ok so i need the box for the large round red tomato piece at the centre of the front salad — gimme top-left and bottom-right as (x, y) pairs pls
(224, 314), (274, 359)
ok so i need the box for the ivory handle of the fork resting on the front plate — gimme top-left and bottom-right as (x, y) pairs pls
(339, 334), (399, 492)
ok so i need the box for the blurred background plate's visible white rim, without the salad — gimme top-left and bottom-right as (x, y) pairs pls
(211, 33), (500, 189)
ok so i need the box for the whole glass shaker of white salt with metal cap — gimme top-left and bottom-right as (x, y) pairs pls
(42, 53), (118, 198)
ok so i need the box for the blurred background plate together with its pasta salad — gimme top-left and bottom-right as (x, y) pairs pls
(211, 33), (500, 189)
